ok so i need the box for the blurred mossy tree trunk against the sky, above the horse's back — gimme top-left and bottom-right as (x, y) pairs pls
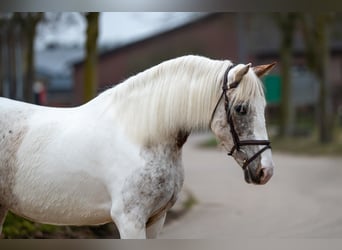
(84, 12), (99, 101)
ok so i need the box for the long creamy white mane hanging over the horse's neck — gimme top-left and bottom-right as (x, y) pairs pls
(101, 56), (264, 144)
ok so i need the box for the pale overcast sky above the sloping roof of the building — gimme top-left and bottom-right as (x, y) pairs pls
(36, 12), (204, 49)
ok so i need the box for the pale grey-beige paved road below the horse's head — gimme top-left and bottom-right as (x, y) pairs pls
(160, 133), (342, 239)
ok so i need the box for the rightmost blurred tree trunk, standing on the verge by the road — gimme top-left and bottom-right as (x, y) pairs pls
(300, 13), (333, 144)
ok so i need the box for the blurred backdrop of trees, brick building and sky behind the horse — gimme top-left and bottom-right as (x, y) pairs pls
(0, 12), (342, 237)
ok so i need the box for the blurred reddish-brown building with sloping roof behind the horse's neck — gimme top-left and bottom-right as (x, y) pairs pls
(74, 14), (239, 104)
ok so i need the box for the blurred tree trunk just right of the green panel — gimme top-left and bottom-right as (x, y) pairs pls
(274, 12), (298, 137)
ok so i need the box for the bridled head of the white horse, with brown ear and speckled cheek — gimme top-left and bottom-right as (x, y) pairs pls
(210, 63), (275, 184)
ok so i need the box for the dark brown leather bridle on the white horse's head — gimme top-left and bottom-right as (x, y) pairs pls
(210, 64), (271, 170)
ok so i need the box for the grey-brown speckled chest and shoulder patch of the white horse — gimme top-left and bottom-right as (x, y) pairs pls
(122, 146), (184, 224)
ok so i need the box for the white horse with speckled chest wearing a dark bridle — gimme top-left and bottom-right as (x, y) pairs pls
(0, 56), (273, 238)
